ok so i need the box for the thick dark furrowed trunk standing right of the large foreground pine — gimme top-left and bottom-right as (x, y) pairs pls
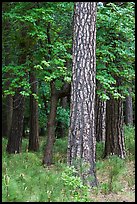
(104, 98), (125, 158)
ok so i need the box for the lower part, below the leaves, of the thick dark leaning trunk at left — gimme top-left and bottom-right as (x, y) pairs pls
(6, 90), (25, 153)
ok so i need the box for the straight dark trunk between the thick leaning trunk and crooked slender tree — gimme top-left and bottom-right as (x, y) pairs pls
(28, 70), (39, 151)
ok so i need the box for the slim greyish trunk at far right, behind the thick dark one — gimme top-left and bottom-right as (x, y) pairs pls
(125, 89), (133, 125)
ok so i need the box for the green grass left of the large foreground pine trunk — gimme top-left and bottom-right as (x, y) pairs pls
(2, 139), (91, 202)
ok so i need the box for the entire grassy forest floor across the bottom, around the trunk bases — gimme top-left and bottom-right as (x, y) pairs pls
(2, 127), (135, 202)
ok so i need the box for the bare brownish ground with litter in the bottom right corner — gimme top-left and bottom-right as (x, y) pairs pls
(91, 161), (135, 202)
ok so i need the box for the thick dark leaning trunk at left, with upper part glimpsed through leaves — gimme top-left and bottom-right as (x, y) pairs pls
(6, 27), (27, 153)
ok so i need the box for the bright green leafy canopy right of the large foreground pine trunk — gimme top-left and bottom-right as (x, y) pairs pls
(96, 2), (135, 100)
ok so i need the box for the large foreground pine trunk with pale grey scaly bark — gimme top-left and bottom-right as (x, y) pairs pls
(67, 2), (97, 186)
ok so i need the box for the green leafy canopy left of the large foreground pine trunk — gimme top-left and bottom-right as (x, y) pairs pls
(2, 2), (73, 100)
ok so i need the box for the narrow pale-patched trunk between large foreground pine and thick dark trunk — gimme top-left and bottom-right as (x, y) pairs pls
(95, 94), (106, 142)
